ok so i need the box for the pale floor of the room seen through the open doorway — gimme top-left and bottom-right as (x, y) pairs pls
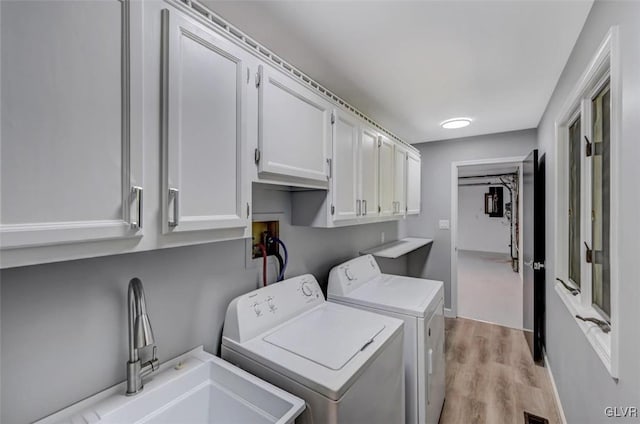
(458, 250), (522, 329)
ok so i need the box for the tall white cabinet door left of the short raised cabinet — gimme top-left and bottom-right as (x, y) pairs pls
(162, 9), (247, 233)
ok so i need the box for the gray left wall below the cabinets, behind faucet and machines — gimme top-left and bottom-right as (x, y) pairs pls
(0, 185), (398, 424)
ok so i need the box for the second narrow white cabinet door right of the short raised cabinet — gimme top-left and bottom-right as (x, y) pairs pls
(359, 127), (378, 218)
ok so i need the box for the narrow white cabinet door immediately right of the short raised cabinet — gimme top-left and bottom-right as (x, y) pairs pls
(331, 111), (362, 221)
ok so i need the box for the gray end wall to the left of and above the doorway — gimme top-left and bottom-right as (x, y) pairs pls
(402, 129), (536, 308)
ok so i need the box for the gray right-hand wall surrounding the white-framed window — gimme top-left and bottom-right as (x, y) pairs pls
(538, 1), (640, 423)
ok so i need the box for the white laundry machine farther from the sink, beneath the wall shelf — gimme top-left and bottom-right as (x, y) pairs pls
(327, 255), (445, 424)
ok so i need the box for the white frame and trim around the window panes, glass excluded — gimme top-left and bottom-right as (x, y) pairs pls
(554, 26), (622, 378)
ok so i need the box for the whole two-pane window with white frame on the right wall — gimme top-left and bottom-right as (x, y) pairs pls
(555, 27), (621, 377)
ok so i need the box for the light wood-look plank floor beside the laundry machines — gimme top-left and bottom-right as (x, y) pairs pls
(440, 318), (561, 424)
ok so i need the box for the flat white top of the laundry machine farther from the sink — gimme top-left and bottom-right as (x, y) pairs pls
(329, 274), (442, 318)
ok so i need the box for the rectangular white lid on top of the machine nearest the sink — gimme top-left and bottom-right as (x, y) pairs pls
(263, 308), (385, 370)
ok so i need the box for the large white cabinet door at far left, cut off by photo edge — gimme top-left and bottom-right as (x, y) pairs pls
(0, 0), (142, 249)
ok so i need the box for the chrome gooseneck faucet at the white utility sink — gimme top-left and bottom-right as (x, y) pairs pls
(127, 278), (159, 396)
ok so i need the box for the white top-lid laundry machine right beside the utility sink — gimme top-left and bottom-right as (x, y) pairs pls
(222, 275), (405, 424)
